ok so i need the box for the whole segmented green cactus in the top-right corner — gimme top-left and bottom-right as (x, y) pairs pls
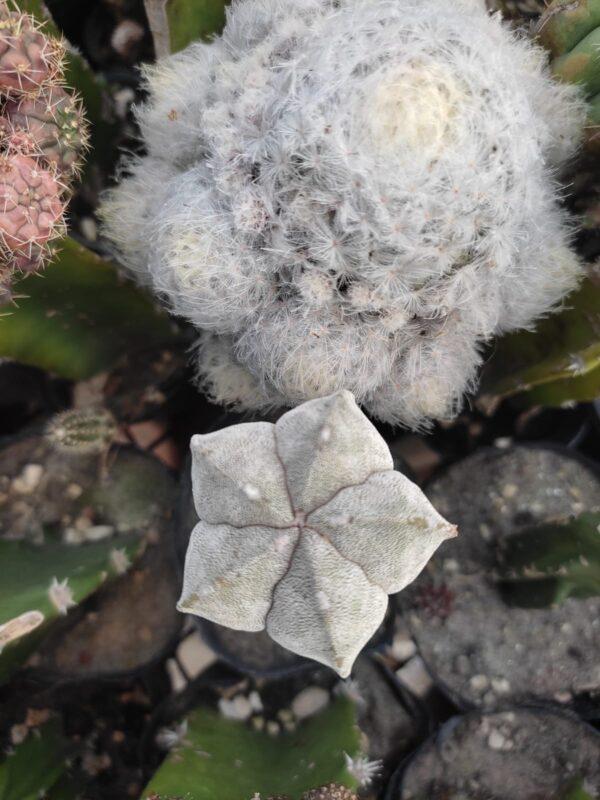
(537, 0), (600, 150)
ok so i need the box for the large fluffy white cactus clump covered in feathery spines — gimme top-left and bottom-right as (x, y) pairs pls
(104, 0), (584, 427)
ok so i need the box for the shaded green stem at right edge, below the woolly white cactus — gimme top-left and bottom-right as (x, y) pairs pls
(480, 275), (600, 407)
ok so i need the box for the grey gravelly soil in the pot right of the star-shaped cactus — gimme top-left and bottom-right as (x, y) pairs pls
(399, 447), (600, 708)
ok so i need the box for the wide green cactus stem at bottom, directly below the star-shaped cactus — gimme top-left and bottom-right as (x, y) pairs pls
(142, 697), (359, 800)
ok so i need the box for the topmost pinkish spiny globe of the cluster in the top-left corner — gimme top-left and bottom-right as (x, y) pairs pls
(0, 2), (65, 96)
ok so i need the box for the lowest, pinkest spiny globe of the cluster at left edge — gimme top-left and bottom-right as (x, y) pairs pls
(0, 153), (65, 283)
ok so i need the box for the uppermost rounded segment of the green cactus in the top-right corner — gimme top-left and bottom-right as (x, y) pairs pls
(537, 0), (600, 56)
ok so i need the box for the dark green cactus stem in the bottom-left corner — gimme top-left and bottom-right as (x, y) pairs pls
(0, 720), (69, 800)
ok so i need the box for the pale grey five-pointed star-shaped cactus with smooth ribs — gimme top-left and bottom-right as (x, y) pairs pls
(178, 391), (456, 677)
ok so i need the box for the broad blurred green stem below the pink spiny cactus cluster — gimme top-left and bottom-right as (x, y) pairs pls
(0, 238), (178, 380)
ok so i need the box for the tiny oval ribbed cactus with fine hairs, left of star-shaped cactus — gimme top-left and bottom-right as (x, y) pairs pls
(46, 409), (117, 455)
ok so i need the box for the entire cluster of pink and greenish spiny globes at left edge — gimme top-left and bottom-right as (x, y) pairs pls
(0, 0), (88, 303)
